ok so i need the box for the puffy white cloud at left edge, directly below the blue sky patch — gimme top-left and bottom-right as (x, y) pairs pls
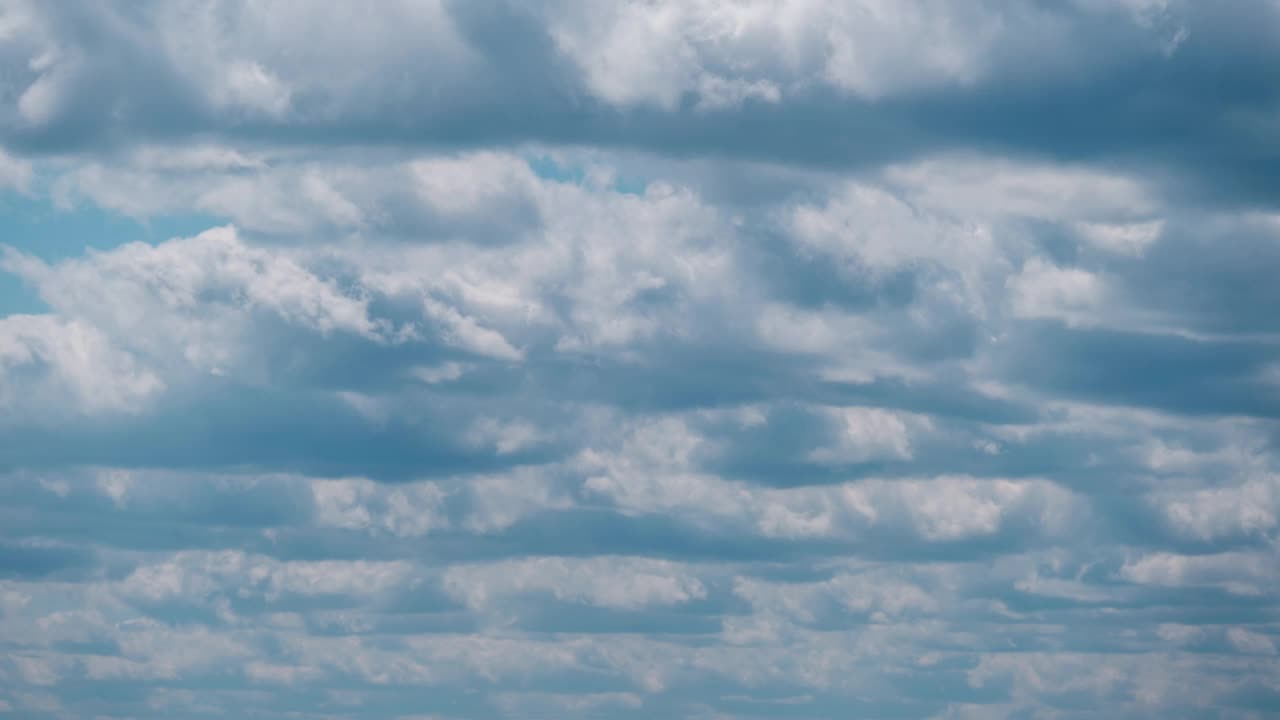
(4, 227), (387, 381)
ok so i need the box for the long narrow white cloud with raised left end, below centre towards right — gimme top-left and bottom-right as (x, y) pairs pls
(576, 419), (1076, 542)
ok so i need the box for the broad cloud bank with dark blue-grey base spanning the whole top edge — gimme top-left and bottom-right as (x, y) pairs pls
(4, 0), (1275, 204)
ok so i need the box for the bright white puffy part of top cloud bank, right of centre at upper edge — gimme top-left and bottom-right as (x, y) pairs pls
(544, 0), (1024, 109)
